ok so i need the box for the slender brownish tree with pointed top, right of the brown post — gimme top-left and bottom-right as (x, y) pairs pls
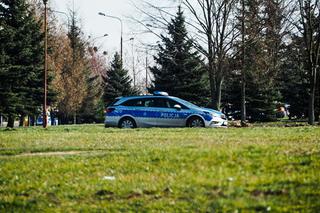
(52, 11), (90, 123)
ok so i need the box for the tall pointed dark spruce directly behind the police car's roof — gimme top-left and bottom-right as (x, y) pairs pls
(150, 7), (209, 104)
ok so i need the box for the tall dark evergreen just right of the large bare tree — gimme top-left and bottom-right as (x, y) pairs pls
(231, 0), (292, 121)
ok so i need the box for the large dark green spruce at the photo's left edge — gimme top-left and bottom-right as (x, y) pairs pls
(0, 0), (43, 127)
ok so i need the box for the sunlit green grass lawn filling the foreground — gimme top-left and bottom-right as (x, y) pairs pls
(0, 125), (320, 212)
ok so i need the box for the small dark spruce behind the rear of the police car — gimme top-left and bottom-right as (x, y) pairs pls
(103, 53), (137, 103)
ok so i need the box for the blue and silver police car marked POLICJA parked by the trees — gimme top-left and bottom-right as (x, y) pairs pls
(105, 92), (228, 128)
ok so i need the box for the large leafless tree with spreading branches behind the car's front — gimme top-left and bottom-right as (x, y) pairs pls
(183, 0), (239, 109)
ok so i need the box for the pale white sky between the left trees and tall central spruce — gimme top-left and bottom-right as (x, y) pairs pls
(49, 0), (182, 85)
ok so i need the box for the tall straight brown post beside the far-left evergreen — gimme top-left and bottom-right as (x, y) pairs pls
(42, 0), (48, 128)
